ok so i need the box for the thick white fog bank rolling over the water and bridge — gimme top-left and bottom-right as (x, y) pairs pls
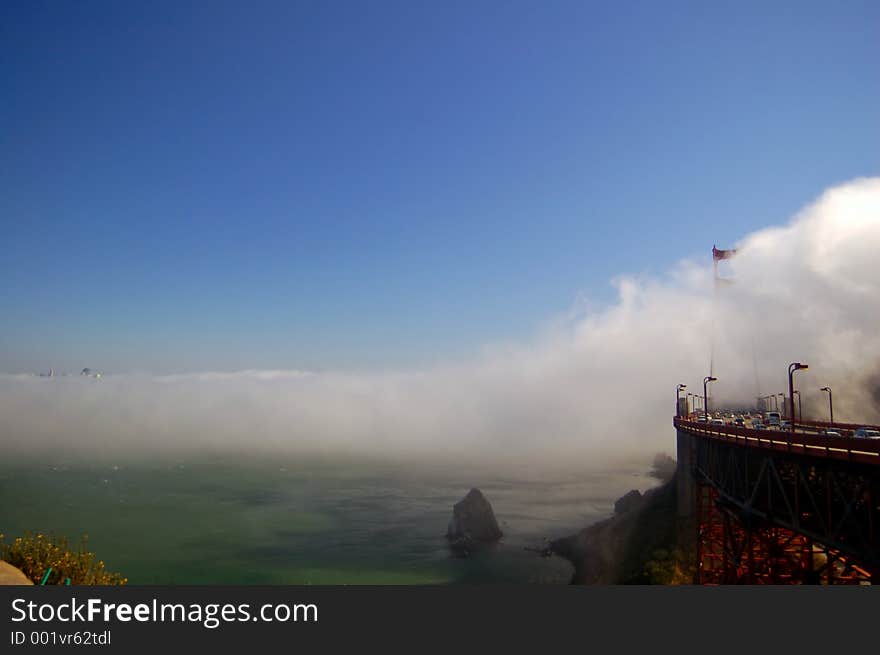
(0, 179), (880, 467)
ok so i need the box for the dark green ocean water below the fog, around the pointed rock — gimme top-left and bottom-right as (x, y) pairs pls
(0, 457), (656, 584)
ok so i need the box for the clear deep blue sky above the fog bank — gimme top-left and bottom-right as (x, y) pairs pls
(0, 2), (880, 372)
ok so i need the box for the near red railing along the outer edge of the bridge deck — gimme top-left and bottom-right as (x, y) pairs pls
(673, 416), (880, 466)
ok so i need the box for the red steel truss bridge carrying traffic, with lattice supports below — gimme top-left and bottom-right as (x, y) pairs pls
(673, 415), (880, 584)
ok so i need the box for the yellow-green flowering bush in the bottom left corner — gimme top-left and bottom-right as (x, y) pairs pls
(0, 532), (128, 585)
